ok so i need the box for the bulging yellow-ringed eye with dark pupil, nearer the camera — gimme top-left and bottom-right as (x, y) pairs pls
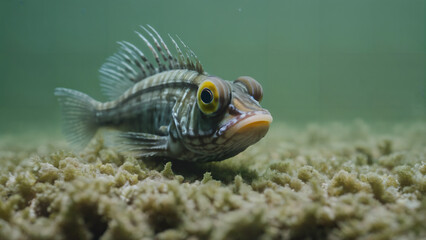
(197, 78), (230, 115)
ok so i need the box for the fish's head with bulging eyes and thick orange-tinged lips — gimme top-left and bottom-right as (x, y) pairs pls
(188, 76), (272, 160)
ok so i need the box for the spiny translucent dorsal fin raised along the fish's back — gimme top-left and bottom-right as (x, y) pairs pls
(99, 25), (204, 100)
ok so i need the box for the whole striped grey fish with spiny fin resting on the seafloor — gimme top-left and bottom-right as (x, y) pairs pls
(54, 25), (272, 162)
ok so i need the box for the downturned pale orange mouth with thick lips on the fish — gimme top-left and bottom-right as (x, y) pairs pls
(216, 110), (272, 138)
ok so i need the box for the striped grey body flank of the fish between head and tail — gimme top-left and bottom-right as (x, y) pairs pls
(96, 70), (200, 136)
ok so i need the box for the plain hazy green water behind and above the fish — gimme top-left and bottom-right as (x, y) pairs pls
(0, 0), (426, 134)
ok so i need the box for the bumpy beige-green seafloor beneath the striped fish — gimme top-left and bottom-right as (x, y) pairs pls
(0, 121), (426, 240)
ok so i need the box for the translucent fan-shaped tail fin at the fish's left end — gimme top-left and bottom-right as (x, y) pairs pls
(55, 88), (99, 148)
